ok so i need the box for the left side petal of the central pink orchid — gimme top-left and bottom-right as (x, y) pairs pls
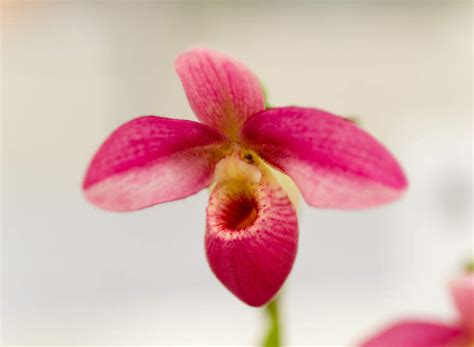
(83, 116), (227, 211)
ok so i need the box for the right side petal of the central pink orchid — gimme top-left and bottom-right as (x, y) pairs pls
(241, 107), (407, 208)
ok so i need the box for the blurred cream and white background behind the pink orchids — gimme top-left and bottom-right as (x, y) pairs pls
(1, 1), (473, 346)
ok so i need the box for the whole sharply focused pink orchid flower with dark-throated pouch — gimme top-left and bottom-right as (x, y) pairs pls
(83, 49), (407, 306)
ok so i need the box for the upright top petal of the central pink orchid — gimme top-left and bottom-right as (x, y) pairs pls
(176, 49), (264, 137)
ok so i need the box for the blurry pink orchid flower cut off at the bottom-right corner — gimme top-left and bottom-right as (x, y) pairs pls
(361, 273), (474, 347)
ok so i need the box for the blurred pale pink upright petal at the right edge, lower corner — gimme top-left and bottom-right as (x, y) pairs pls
(451, 273), (474, 340)
